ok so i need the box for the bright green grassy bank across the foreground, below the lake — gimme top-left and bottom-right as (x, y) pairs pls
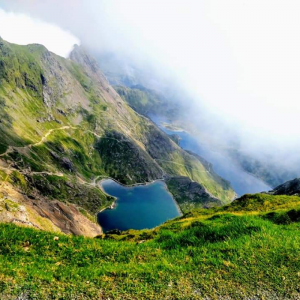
(0, 195), (300, 299)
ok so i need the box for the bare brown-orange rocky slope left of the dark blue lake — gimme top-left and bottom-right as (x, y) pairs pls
(0, 183), (102, 237)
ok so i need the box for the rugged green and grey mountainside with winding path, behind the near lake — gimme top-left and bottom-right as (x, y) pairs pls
(0, 40), (235, 236)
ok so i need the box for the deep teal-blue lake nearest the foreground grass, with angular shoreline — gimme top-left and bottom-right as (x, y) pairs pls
(97, 179), (180, 232)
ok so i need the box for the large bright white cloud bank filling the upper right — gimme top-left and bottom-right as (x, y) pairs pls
(106, 0), (300, 144)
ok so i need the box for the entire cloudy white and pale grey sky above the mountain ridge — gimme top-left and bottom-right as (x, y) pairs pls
(0, 0), (300, 169)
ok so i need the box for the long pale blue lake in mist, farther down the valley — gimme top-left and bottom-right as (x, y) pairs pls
(151, 116), (272, 196)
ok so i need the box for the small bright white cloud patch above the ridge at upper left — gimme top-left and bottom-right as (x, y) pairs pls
(0, 9), (79, 57)
